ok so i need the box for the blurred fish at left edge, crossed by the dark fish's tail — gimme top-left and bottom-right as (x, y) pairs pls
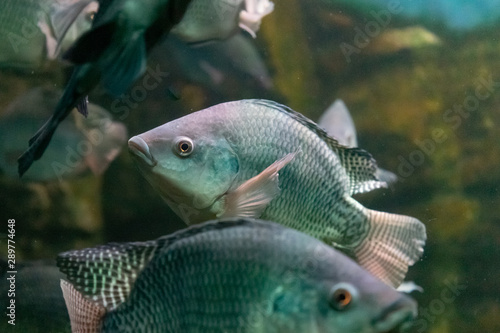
(0, 87), (127, 181)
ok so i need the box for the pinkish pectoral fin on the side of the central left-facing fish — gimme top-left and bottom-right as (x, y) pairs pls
(218, 153), (296, 218)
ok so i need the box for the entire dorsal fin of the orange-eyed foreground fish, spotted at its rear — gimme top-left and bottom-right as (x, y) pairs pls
(57, 218), (280, 311)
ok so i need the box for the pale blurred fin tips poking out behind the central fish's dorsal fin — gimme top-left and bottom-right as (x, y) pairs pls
(318, 99), (398, 184)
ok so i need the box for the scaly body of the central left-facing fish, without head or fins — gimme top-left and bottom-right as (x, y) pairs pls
(209, 102), (369, 247)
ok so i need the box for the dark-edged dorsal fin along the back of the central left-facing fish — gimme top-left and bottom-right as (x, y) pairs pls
(244, 99), (387, 195)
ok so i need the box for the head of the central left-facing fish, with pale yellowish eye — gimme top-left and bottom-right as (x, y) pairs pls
(129, 112), (239, 224)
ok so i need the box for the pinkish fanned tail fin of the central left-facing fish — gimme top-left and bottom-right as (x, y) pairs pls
(355, 209), (427, 287)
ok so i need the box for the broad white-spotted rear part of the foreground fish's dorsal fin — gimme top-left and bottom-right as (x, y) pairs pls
(57, 241), (158, 311)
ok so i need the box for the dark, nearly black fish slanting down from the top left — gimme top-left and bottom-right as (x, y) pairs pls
(18, 0), (190, 176)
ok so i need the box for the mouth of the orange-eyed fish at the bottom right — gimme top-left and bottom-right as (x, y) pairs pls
(372, 297), (417, 333)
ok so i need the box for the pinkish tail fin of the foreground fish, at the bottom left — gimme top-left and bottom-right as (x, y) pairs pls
(61, 280), (106, 332)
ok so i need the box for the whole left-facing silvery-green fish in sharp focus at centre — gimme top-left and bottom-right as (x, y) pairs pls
(129, 100), (426, 286)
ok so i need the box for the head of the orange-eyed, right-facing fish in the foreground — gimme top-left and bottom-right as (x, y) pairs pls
(261, 237), (417, 333)
